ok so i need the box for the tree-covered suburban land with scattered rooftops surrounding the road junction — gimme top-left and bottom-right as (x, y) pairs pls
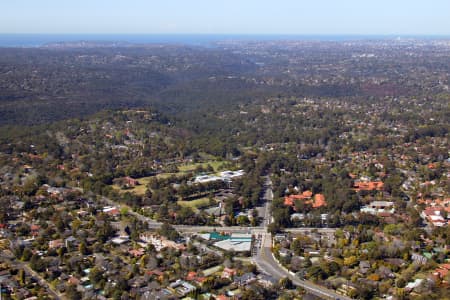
(0, 41), (450, 299)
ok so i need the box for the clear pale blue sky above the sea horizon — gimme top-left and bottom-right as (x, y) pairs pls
(0, 0), (450, 35)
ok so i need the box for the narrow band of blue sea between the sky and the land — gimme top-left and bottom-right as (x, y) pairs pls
(0, 34), (450, 48)
